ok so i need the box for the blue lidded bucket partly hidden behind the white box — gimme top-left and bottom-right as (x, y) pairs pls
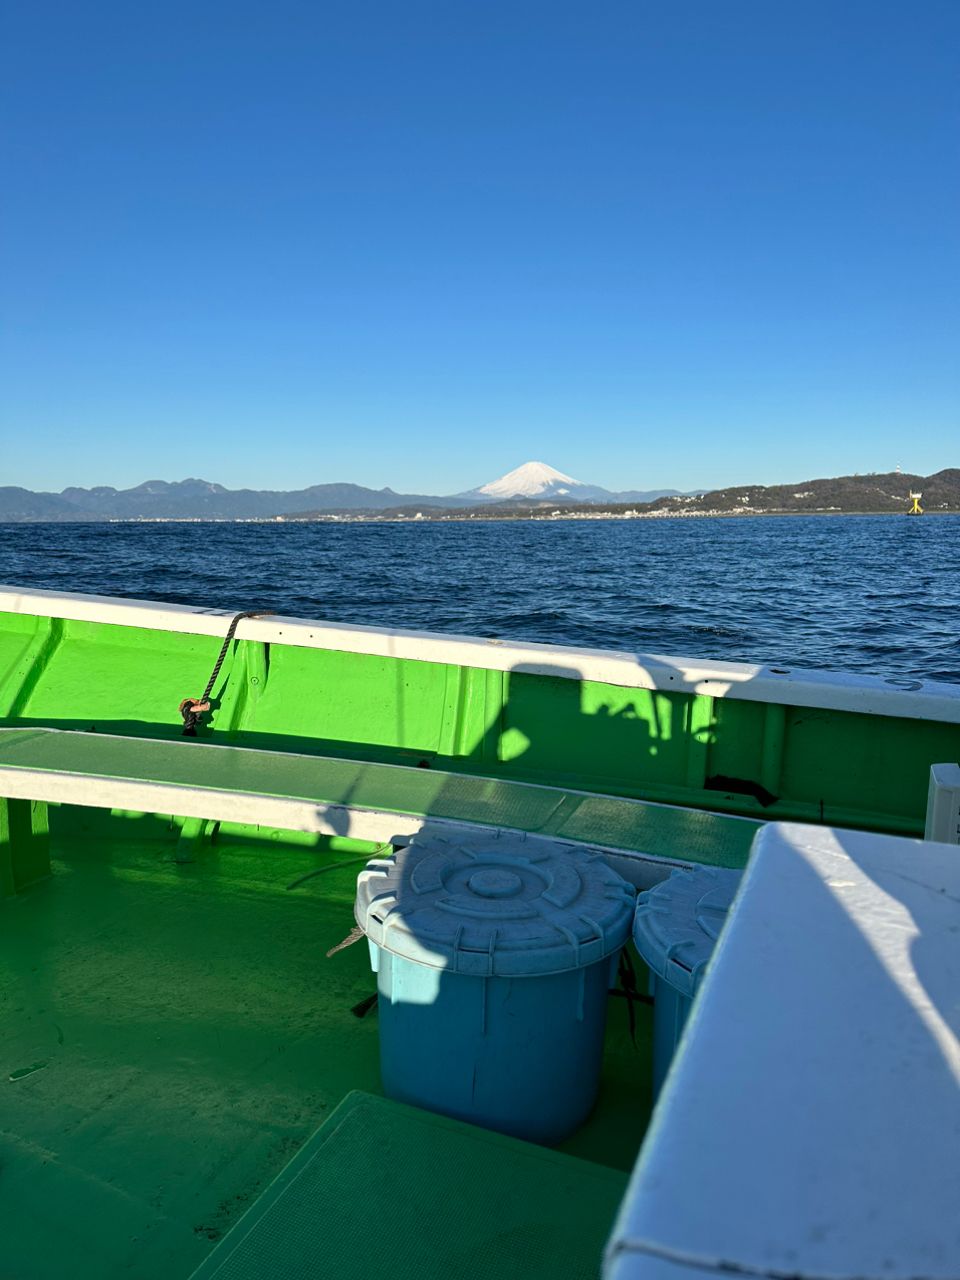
(634, 867), (742, 1097)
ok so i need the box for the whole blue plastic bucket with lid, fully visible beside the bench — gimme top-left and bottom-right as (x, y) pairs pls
(356, 835), (636, 1143)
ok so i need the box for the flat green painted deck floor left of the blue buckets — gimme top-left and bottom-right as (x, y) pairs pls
(0, 819), (650, 1280)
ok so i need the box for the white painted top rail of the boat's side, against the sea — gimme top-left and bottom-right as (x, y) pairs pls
(0, 586), (960, 724)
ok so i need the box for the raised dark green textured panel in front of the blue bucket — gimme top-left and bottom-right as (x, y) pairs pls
(195, 1093), (627, 1280)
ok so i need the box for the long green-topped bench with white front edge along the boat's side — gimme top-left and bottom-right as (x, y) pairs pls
(0, 727), (759, 897)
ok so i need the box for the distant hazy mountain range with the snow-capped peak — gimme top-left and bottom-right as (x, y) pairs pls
(0, 462), (676, 521)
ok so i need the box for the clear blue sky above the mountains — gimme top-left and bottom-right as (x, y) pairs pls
(0, 0), (960, 493)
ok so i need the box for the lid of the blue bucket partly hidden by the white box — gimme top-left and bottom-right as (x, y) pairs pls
(634, 867), (744, 996)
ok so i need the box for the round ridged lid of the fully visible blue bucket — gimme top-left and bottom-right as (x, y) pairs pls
(355, 832), (636, 977)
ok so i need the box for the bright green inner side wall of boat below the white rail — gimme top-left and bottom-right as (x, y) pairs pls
(0, 593), (960, 835)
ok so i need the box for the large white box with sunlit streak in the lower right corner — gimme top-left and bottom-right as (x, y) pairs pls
(604, 823), (960, 1280)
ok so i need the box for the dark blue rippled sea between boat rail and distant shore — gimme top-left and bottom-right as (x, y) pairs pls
(0, 516), (960, 682)
